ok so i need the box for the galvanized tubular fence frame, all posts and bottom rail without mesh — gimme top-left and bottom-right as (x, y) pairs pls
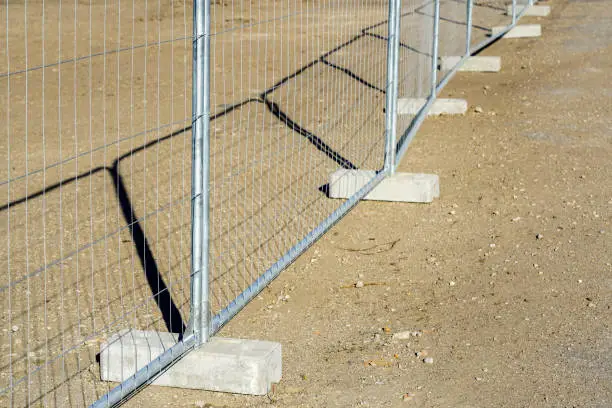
(76, 0), (534, 408)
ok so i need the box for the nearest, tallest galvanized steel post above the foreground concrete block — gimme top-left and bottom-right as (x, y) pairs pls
(189, 0), (210, 344)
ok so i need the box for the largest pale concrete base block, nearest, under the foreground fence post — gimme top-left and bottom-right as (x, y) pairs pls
(100, 331), (282, 395)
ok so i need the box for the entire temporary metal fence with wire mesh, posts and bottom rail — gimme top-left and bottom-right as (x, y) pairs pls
(0, 0), (540, 407)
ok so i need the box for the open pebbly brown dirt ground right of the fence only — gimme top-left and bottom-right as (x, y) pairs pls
(127, 0), (612, 408)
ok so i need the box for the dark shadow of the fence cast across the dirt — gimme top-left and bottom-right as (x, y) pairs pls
(0, 5), (438, 404)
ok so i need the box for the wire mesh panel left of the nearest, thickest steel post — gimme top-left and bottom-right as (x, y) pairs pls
(0, 0), (192, 407)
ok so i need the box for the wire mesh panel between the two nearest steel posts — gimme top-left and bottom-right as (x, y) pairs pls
(210, 0), (388, 330)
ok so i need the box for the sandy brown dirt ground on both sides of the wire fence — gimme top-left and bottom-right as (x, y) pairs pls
(0, 0), (612, 408)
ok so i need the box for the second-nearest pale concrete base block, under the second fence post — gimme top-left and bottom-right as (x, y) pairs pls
(329, 169), (440, 203)
